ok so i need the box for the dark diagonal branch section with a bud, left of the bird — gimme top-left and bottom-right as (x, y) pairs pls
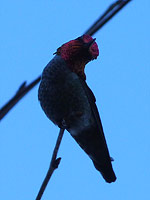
(0, 76), (41, 120)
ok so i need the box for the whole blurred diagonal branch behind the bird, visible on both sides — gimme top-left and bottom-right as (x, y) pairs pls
(0, 0), (131, 120)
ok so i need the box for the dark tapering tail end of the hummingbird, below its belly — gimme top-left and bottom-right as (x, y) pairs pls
(72, 127), (116, 183)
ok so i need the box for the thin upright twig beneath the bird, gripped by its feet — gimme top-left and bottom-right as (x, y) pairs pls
(36, 129), (64, 200)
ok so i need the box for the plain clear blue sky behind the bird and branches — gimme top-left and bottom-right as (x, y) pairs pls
(0, 0), (150, 200)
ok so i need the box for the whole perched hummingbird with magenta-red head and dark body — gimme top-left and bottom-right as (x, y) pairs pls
(38, 35), (116, 183)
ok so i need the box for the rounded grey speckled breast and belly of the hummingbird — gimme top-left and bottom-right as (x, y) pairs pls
(38, 56), (92, 131)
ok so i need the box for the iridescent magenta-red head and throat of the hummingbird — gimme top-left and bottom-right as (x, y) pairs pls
(55, 35), (99, 79)
